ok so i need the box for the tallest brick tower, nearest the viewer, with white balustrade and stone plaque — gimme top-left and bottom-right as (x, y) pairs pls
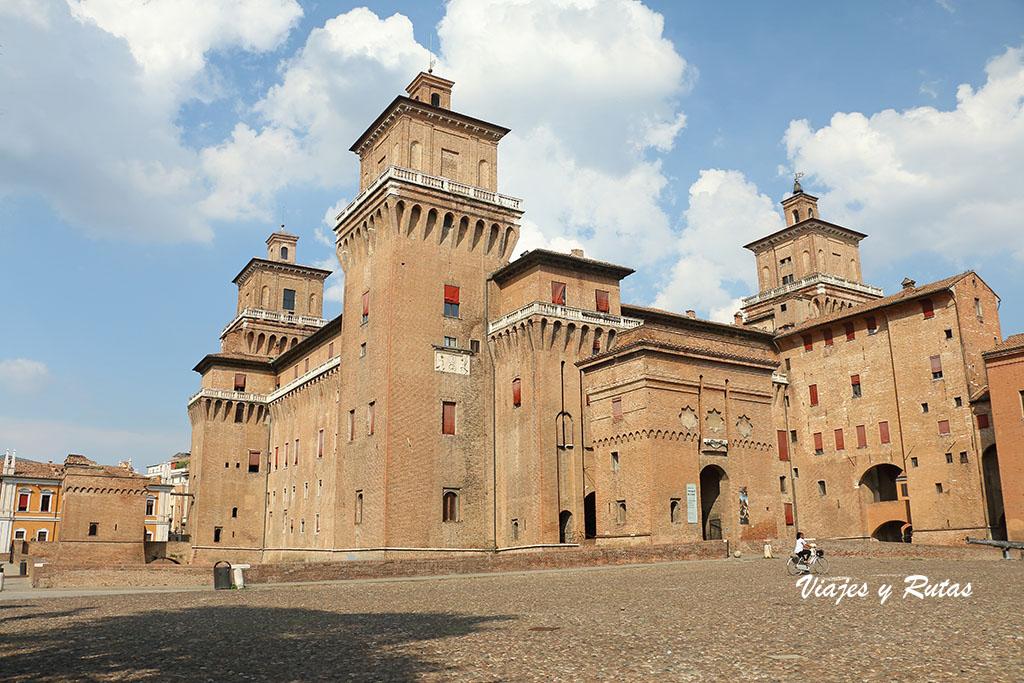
(334, 73), (522, 547)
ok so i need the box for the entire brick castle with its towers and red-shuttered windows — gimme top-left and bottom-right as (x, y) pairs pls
(188, 73), (1024, 562)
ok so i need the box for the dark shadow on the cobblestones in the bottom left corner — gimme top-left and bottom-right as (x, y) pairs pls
(0, 606), (515, 681)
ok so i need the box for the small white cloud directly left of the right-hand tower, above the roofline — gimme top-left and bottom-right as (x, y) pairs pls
(653, 169), (783, 323)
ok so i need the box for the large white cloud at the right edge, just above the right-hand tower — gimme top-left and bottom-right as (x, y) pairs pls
(784, 48), (1024, 266)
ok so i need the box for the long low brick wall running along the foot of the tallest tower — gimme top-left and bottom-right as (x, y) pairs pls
(246, 541), (725, 584)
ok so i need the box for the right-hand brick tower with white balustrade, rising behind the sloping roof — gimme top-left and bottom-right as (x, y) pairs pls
(742, 176), (882, 331)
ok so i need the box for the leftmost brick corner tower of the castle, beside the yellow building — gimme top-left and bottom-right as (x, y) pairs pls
(186, 229), (331, 562)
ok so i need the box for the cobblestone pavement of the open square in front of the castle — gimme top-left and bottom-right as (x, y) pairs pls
(0, 557), (1024, 681)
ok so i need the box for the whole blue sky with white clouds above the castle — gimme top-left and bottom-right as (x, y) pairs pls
(0, 0), (1024, 466)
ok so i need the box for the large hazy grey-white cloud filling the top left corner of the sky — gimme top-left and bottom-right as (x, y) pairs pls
(0, 0), (298, 242)
